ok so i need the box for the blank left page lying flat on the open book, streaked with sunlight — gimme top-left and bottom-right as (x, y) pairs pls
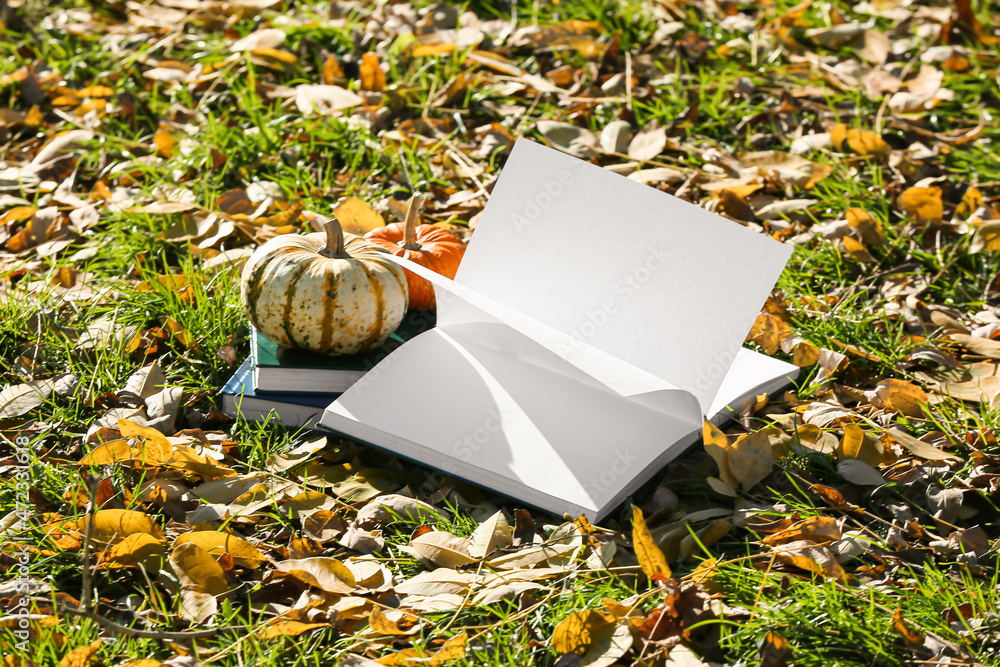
(322, 325), (698, 516)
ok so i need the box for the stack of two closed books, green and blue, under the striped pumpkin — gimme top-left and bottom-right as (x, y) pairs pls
(222, 310), (434, 429)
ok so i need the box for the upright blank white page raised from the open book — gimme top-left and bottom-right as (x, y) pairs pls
(452, 139), (791, 413)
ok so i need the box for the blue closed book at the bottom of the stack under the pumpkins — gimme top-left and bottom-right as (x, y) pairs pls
(222, 358), (340, 429)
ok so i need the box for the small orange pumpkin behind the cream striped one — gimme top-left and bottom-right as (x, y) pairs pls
(365, 195), (465, 310)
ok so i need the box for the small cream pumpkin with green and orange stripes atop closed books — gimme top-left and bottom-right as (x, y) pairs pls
(240, 220), (408, 355)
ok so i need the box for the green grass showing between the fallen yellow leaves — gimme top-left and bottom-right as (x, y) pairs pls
(0, 0), (1000, 667)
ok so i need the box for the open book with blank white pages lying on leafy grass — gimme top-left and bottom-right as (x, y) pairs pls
(319, 139), (797, 521)
